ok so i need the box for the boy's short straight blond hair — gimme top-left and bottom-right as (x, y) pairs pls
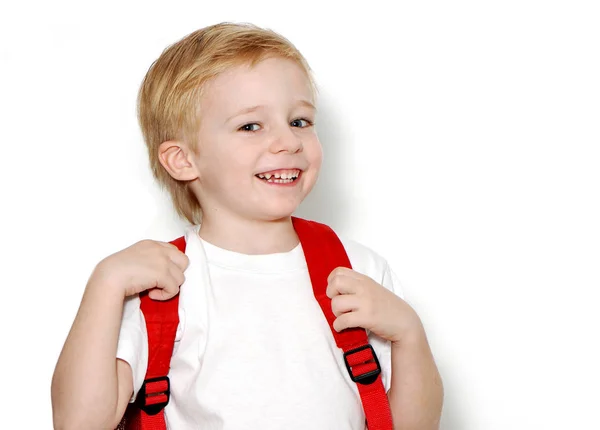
(138, 23), (316, 224)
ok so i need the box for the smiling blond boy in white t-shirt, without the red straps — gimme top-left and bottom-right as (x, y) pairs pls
(52, 24), (442, 430)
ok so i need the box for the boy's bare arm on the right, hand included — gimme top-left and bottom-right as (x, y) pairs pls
(327, 267), (443, 430)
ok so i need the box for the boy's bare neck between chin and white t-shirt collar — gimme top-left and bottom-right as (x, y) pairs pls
(199, 213), (299, 254)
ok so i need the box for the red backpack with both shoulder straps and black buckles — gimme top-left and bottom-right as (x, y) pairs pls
(117, 217), (393, 430)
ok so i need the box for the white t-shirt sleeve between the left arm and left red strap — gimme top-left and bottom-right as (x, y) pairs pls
(117, 295), (148, 401)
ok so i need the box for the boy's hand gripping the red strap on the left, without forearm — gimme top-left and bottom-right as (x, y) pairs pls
(89, 240), (189, 300)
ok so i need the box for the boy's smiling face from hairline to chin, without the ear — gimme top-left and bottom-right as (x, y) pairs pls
(194, 58), (322, 220)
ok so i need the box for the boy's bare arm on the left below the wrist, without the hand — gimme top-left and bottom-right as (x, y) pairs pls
(52, 276), (133, 429)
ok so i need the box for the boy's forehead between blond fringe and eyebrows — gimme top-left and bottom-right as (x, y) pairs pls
(201, 58), (314, 114)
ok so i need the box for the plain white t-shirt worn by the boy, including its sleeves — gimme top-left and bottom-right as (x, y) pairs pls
(117, 227), (400, 430)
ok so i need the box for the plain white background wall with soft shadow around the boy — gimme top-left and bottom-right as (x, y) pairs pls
(0, 0), (600, 430)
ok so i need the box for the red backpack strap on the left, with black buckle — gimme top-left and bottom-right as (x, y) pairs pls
(126, 236), (186, 430)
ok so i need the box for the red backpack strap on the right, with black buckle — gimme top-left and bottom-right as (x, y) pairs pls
(292, 217), (393, 430)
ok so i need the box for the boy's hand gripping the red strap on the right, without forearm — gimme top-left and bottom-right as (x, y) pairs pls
(327, 267), (422, 342)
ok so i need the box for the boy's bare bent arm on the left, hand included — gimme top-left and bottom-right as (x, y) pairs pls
(52, 241), (188, 430)
